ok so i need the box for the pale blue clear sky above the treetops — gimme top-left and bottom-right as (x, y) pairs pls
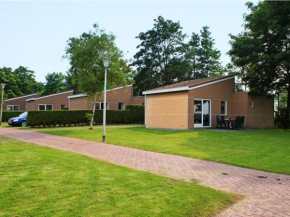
(0, 0), (257, 82)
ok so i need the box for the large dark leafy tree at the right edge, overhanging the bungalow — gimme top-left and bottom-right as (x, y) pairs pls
(229, 1), (290, 127)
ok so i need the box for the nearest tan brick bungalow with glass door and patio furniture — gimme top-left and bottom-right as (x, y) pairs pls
(143, 75), (274, 130)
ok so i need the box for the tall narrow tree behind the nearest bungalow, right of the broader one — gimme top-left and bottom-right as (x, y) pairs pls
(196, 26), (222, 78)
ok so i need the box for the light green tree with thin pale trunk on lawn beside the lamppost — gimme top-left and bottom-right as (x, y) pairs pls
(64, 24), (131, 129)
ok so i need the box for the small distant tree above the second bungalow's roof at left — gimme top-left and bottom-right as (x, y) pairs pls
(43, 72), (67, 95)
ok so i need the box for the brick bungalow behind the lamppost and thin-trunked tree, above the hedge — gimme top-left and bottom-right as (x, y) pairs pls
(68, 85), (144, 110)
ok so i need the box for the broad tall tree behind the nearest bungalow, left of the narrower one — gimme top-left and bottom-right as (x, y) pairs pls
(131, 16), (185, 94)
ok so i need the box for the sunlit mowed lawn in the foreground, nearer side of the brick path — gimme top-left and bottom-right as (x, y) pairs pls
(0, 137), (237, 217)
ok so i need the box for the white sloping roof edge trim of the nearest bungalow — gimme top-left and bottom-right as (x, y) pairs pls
(142, 75), (235, 95)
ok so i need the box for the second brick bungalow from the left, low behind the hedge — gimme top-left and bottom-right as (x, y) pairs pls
(26, 90), (73, 111)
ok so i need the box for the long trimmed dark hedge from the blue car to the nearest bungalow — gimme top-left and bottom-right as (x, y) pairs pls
(27, 105), (144, 127)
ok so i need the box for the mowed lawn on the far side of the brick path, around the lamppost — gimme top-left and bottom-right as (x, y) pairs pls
(26, 126), (290, 174)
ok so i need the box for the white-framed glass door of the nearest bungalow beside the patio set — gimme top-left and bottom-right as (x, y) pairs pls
(194, 99), (211, 128)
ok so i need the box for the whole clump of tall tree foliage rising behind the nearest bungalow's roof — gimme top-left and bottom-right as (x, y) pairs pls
(131, 16), (224, 95)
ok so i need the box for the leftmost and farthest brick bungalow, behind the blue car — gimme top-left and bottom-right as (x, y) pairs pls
(4, 93), (37, 111)
